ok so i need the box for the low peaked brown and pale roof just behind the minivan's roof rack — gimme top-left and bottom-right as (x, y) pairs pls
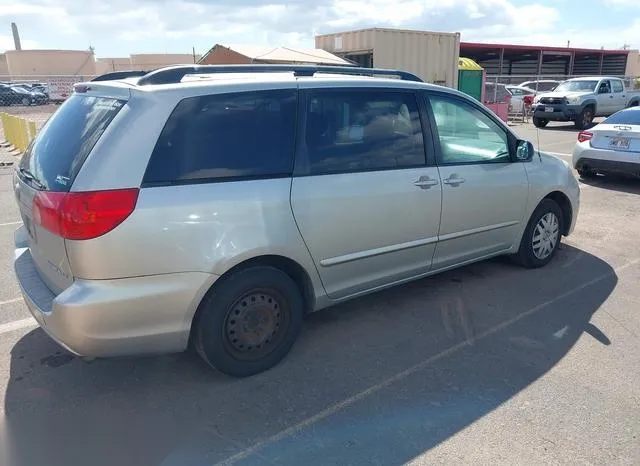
(198, 44), (351, 65)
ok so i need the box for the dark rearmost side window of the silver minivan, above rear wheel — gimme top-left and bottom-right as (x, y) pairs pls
(144, 89), (297, 184)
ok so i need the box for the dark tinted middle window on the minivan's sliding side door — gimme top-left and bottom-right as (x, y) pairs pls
(296, 90), (425, 175)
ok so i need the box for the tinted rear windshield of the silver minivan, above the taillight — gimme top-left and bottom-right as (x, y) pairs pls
(20, 94), (125, 192)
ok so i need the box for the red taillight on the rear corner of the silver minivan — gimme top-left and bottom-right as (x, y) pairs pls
(33, 188), (138, 240)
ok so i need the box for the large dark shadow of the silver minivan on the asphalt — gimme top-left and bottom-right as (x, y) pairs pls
(4, 245), (617, 466)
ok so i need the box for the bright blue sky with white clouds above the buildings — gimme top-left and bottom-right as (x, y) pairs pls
(0, 0), (640, 57)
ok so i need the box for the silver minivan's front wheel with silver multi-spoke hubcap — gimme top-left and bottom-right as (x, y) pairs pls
(515, 199), (564, 268)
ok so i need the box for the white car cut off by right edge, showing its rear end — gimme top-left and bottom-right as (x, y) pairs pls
(573, 106), (640, 178)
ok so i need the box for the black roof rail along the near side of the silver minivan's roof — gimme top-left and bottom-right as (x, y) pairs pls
(138, 65), (423, 86)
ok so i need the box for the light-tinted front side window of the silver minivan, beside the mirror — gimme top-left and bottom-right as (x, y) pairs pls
(429, 95), (511, 165)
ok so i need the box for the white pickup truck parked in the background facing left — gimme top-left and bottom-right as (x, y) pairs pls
(532, 76), (640, 129)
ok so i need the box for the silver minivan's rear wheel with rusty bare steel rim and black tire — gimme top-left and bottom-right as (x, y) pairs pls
(194, 266), (304, 377)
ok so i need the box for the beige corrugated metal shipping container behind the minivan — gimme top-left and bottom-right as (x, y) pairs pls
(316, 28), (460, 88)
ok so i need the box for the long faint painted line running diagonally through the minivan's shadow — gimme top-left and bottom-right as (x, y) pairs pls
(216, 257), (640, 465)
